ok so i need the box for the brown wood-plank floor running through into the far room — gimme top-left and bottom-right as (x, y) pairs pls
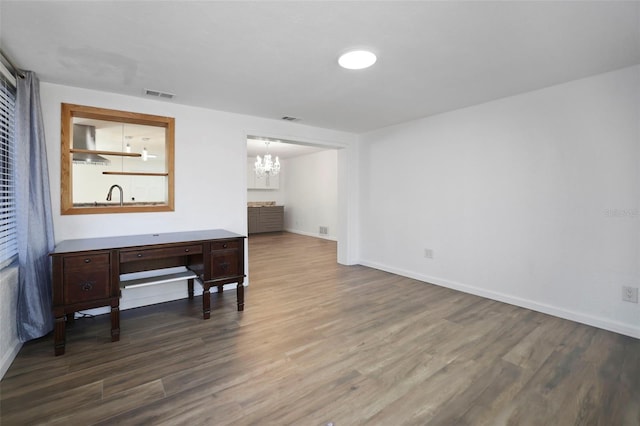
(0, 233), (640, 426)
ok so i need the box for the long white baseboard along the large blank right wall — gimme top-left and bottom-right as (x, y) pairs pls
(360, 261), (640, 339)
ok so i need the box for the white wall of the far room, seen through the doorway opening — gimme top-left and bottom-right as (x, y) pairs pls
(281, 149), (338, 240)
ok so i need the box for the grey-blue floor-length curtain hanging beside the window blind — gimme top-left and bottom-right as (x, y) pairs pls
(15, 71), (54, 342)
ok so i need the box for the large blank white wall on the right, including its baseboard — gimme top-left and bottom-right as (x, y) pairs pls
(359, 66), (640, 337)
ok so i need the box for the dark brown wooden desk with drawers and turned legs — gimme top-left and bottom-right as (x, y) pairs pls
(50, 229), (245, 355)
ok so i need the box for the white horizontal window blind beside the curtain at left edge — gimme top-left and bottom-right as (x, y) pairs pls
(0, 61), (18, 269)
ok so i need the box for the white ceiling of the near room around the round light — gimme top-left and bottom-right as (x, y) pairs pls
(0, 0), (640, 133)
